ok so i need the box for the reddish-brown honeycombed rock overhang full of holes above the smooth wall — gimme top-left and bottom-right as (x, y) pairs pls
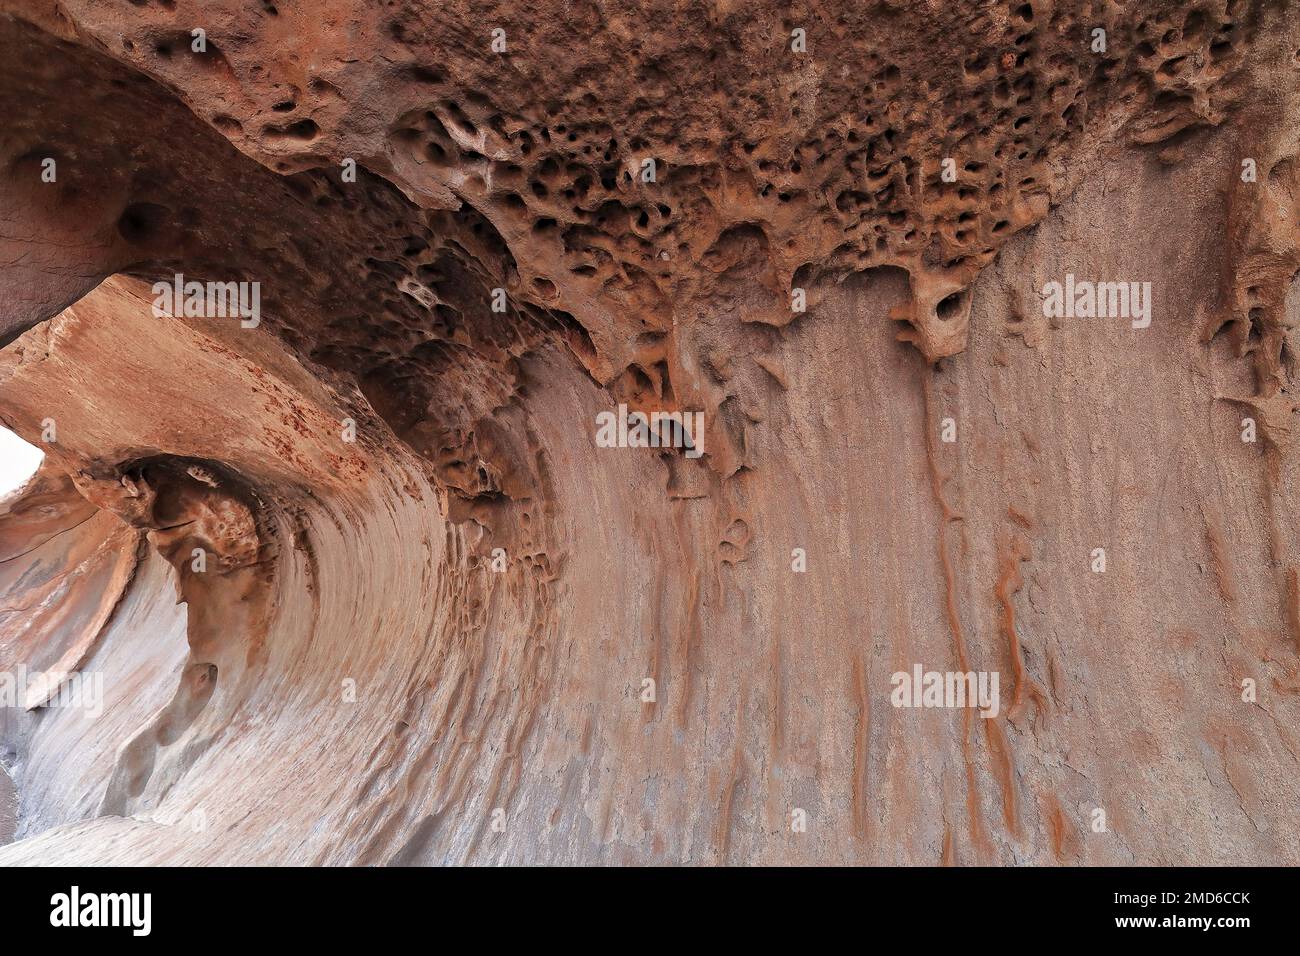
(5, 0), (1262, 444)
